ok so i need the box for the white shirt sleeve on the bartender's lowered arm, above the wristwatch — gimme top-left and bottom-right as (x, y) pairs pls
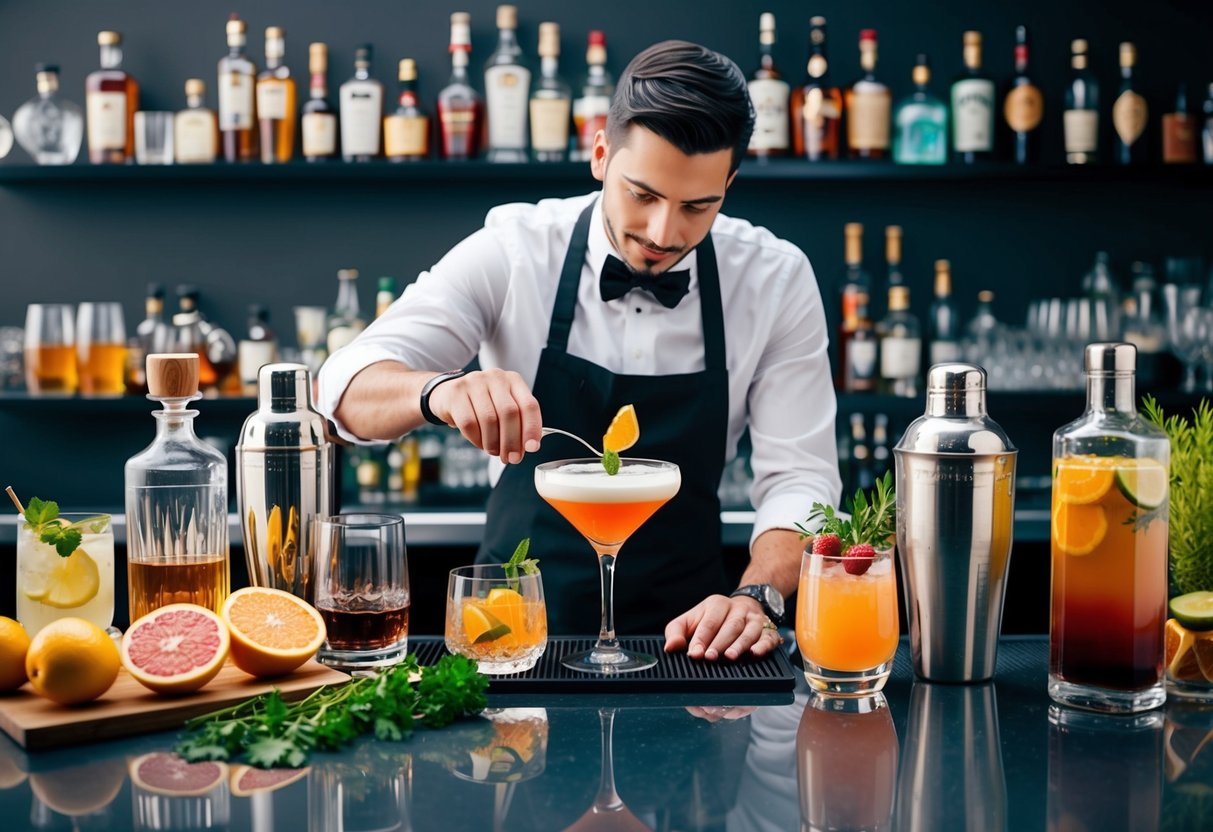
(747, 253), (842, 543)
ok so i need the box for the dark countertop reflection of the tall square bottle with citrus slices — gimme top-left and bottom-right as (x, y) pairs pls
(1046, 705), (1163, 832)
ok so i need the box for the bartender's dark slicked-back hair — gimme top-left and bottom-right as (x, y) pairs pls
(607, 40), (754, 173)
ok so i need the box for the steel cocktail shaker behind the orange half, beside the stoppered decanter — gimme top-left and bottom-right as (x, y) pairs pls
(235, 364), (332, 603)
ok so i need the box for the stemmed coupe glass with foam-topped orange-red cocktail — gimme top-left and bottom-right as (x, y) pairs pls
(535, 458), (682, 673)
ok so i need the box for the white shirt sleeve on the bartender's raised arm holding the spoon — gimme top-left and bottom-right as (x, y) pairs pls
(318, 228), (509, 444)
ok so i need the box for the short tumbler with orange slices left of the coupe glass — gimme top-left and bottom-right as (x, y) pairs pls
(446, 564), (547, 673)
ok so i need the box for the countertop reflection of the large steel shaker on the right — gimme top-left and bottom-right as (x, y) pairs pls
(896, 682), (1007, 832)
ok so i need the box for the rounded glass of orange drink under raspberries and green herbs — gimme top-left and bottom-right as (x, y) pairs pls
(796, 546), (900, 696)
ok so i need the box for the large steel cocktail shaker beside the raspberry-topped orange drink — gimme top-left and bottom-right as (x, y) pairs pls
(893, 364), (1018, 682)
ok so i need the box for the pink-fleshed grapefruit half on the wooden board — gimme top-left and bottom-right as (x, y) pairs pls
(123, 604), (229, 694)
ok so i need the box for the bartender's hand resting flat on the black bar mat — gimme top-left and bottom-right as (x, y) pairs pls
(666, 595), (784, 661)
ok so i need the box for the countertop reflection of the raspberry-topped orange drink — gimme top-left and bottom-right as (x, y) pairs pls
(796, 694), (898, 832)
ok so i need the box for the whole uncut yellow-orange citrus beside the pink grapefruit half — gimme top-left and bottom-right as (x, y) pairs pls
(25, 617), (120, 705)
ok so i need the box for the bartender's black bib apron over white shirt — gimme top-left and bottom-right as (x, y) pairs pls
(477, 204), (730, 636)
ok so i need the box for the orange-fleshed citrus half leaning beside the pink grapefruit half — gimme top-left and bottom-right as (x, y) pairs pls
(220, 587), (325, 677)
